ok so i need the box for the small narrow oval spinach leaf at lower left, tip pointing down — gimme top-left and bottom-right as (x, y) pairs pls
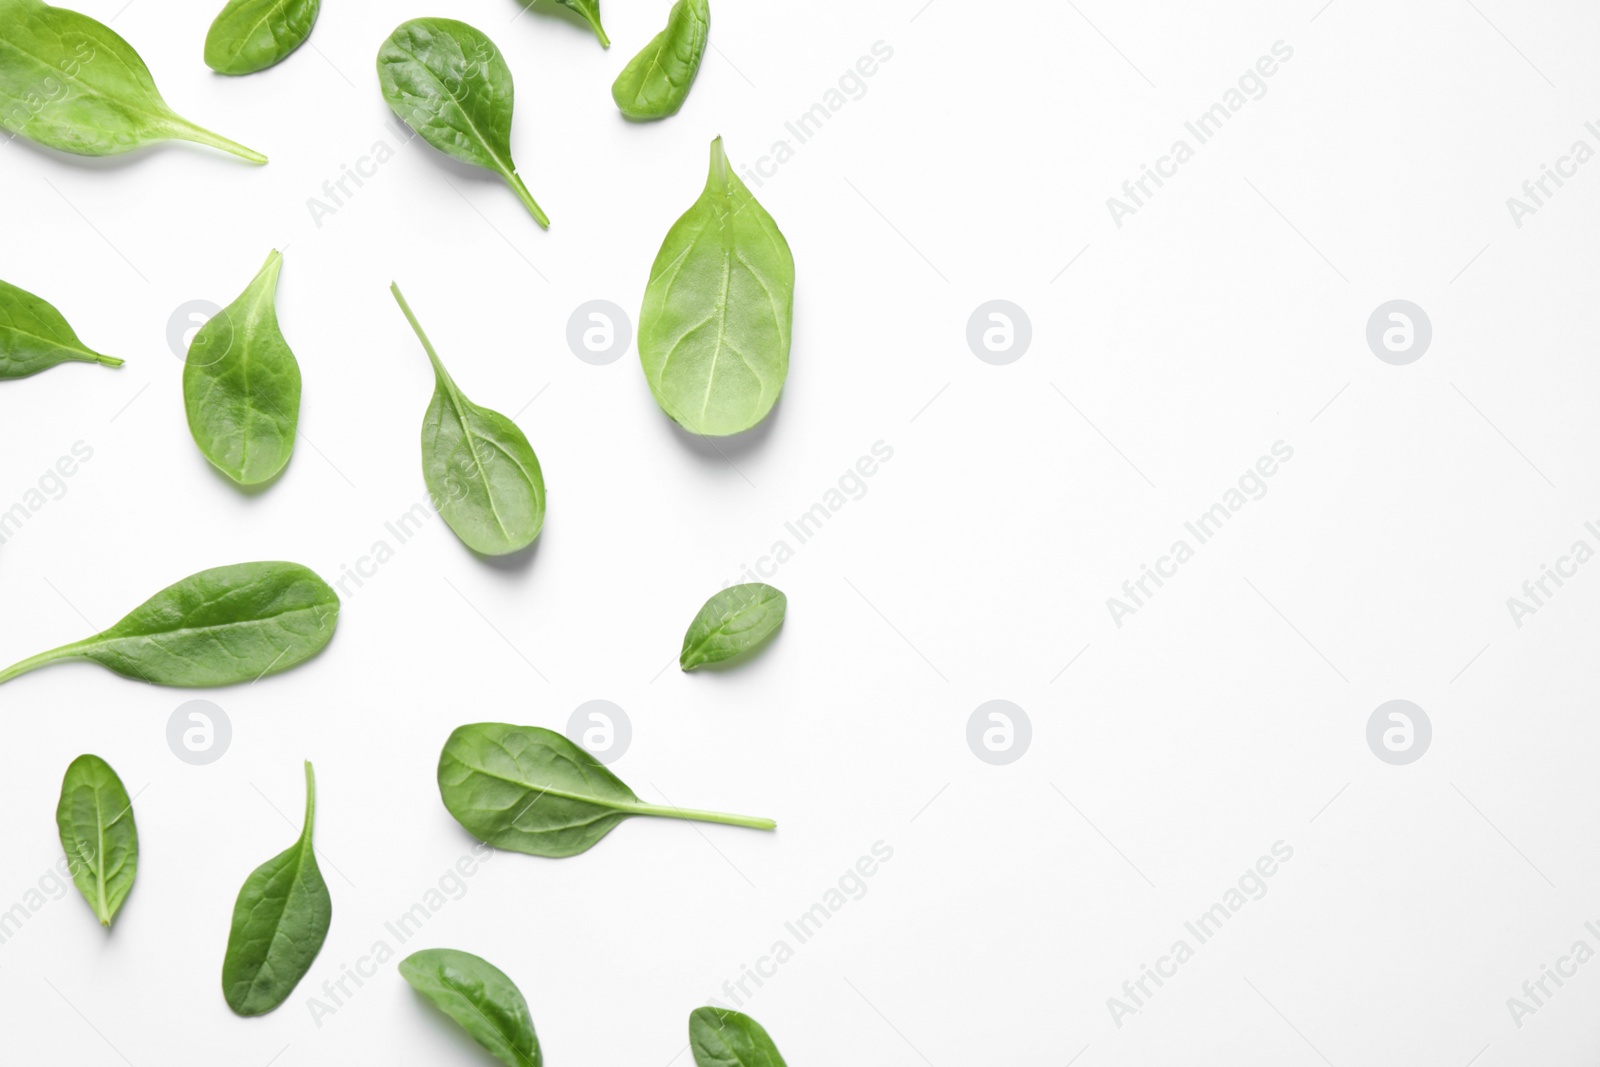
(56, 755), (139, 926)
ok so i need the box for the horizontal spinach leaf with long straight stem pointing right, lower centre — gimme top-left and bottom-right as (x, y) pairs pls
(438, 723), (778, 857)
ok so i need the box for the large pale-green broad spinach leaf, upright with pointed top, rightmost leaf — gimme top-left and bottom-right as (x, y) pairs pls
(638, 138), (795, 437)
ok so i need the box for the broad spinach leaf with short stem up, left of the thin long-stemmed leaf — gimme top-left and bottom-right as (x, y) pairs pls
(184, 251), (301, 485)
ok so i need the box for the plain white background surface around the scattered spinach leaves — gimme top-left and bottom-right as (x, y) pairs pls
(0, 0), (1600, 1067)
